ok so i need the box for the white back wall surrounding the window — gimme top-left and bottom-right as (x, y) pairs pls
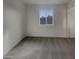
(25, 5), (67, 37)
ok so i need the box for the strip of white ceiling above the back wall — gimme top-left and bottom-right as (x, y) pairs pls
(22, 0), (70, 4)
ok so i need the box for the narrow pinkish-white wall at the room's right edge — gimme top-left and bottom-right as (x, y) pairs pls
(67, 0), (75, 38)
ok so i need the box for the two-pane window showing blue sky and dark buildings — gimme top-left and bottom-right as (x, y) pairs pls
(40, 9), (54, 25)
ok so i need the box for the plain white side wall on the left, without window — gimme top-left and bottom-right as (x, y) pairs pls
(3, 0), (24, 55)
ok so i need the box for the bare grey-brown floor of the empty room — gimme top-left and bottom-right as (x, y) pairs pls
(4, 37), (75, 59)
